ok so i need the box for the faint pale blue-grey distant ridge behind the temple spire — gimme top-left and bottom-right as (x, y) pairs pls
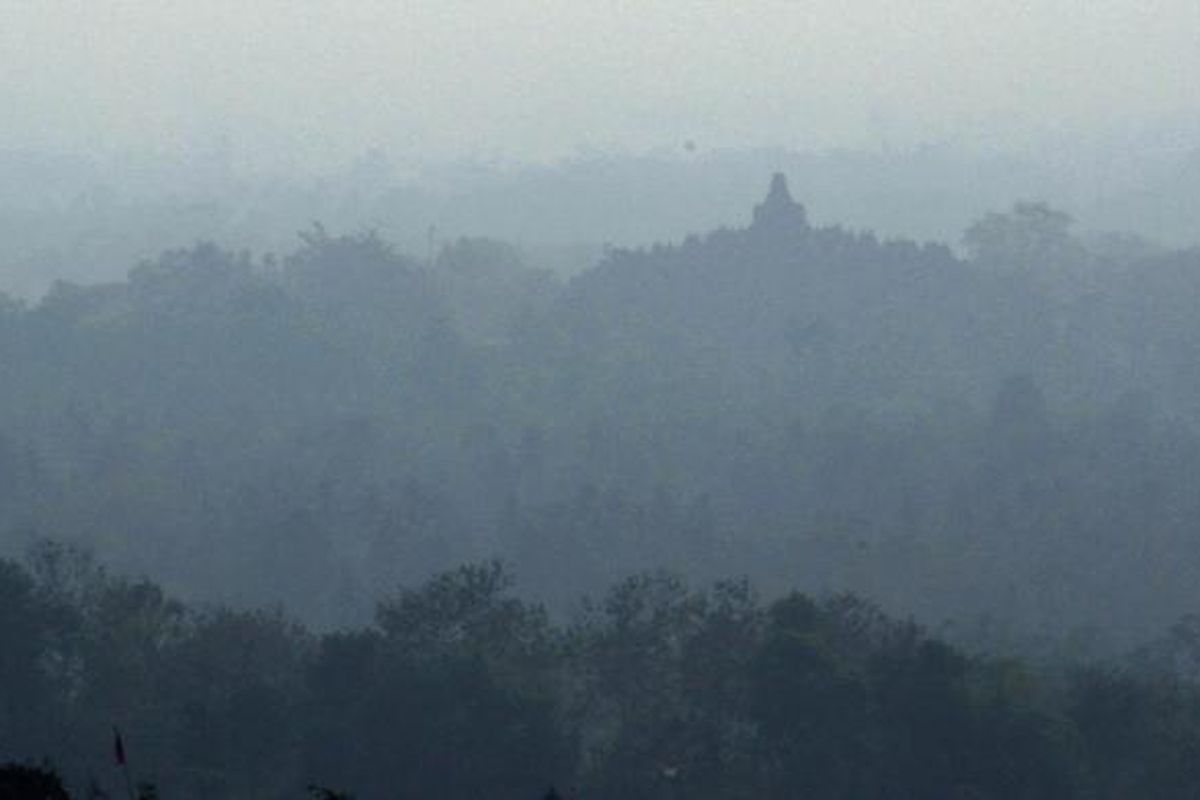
(0, 139), (1200, 300)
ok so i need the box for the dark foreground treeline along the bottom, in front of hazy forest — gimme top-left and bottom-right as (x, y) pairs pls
(7, 545), (1200, 800)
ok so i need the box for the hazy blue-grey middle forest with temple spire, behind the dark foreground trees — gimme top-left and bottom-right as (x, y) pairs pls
(0, 179), (1200, 646)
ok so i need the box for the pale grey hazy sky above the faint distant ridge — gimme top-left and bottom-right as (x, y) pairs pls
(0, 0), (1200, 163)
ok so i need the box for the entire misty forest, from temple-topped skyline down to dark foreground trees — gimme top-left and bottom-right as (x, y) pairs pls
(0, 174), (1200, 799)
